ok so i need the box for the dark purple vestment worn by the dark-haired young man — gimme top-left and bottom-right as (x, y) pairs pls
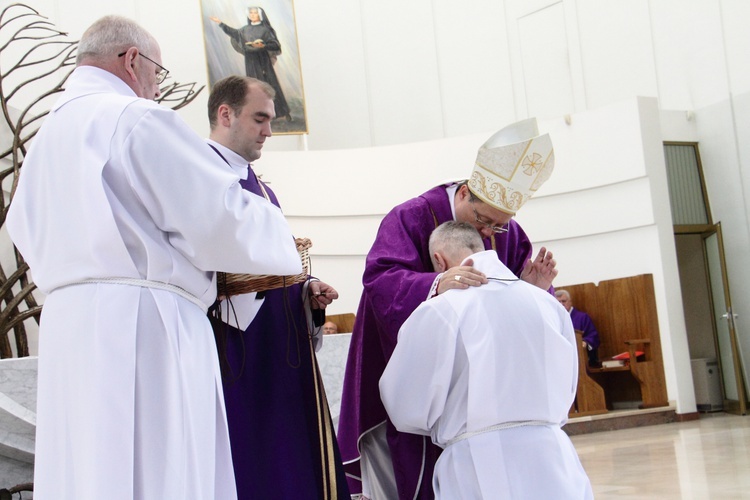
(214, 169), (349, 500)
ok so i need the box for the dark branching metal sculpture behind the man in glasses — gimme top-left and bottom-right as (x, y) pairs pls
(0, 3), (204, 358)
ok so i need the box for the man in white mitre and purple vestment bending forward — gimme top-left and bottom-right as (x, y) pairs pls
(338, 119), (557, 500)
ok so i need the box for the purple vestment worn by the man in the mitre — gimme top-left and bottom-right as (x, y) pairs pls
(338, 185), (532, 499)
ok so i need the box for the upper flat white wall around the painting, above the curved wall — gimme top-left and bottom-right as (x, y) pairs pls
(10, 0), (750, 146)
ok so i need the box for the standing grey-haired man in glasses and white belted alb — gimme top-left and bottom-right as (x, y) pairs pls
(7, 16), (302, 500)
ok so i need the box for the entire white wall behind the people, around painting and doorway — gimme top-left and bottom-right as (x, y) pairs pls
(8, 0), (750, 411)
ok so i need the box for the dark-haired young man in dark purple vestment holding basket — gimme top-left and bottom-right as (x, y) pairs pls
(208, 76), (349, 500)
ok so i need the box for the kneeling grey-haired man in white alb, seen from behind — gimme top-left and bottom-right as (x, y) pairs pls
(379, 221), (593, 500)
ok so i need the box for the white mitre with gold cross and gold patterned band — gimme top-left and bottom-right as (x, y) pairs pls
(468, 118), (555, 214)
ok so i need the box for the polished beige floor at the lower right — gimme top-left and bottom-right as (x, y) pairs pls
(571, 413), (750, 500)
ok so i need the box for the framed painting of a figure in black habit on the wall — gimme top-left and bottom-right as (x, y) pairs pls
(201, 0), (307, 134)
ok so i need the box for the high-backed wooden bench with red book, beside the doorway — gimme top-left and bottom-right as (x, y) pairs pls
(556, 274), (669, 417)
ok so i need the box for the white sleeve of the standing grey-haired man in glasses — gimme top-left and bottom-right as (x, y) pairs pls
(115, 107), (302, 275)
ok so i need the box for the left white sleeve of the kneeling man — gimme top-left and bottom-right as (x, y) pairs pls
(380, 297), (458, 435)
